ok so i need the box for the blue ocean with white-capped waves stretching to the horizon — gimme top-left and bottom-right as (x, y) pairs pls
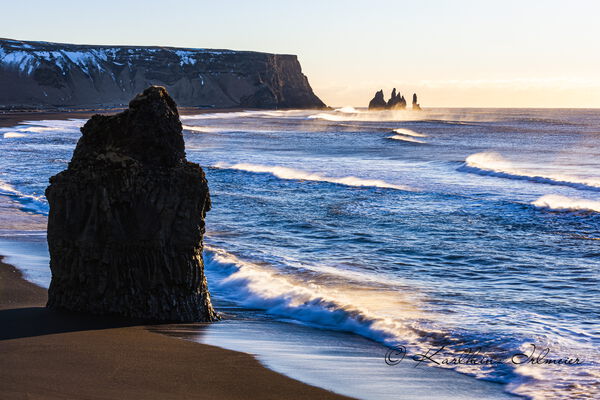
(0, 107), (600, 399)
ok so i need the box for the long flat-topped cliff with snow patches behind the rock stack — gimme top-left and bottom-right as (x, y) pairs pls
(0, 39), (325, 108)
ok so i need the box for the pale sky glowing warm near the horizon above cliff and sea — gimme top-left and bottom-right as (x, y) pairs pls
(0, 0), (600, 107)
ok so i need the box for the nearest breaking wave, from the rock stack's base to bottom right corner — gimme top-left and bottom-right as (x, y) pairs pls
(204, 245), (597, 399)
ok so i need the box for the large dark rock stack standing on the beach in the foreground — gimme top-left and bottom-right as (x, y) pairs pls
(46, 86), (216, 321)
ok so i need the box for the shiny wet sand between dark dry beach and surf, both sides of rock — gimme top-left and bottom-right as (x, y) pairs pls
(0, 232), (520, 400)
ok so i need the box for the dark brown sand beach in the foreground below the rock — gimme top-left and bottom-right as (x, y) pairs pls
(0, 257), (348, 399)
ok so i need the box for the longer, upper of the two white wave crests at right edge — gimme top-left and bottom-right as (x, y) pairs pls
(459, 152), (600, 191)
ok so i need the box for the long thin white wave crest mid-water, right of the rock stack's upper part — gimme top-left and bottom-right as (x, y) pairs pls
(215, 163), (415, 191)
